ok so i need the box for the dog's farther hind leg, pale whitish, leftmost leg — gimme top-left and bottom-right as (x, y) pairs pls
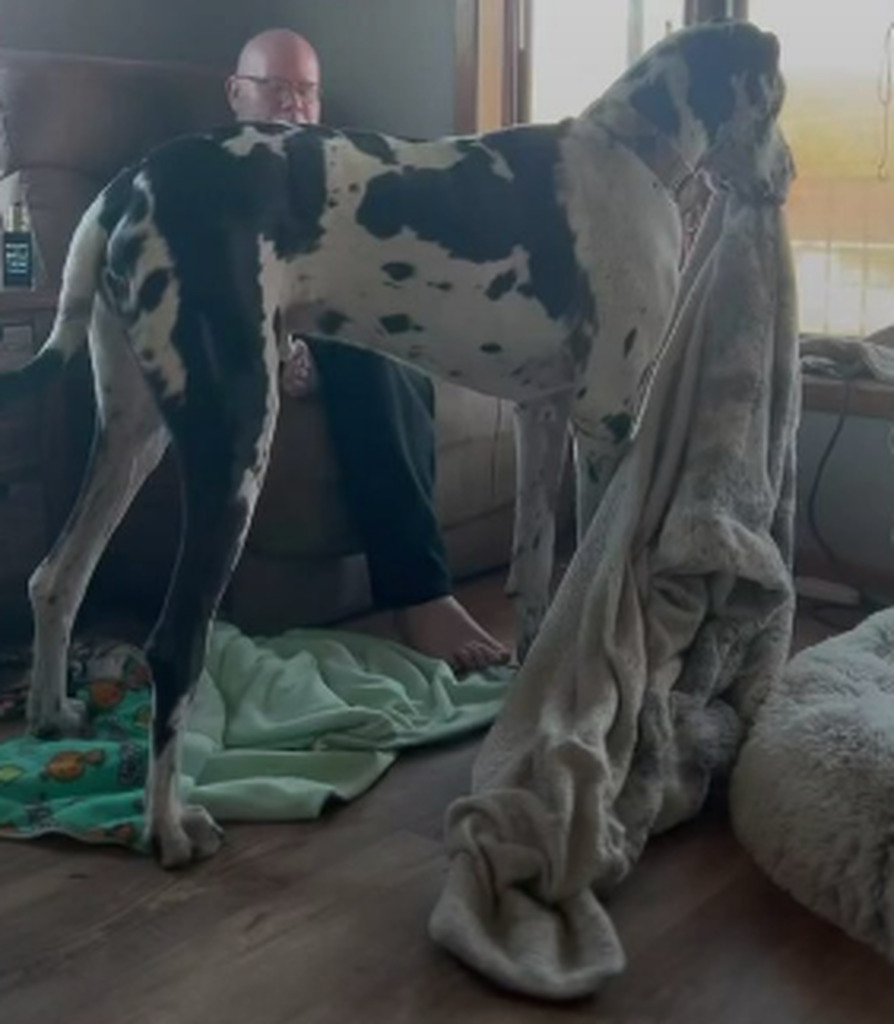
(28, 301), (167, 735)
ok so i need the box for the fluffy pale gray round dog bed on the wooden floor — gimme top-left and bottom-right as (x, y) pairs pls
(731, 610), (894, 959)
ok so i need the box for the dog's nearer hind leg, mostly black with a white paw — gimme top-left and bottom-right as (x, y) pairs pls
(146, 303), (279, 867)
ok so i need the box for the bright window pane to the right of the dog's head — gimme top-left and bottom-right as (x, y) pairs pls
(750, 0), (894, 336)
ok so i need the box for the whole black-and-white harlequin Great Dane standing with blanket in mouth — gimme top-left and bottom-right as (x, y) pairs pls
(0, 23), (785, 866)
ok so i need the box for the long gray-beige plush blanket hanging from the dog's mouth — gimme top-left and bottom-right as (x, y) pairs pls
(430, 197), (799, 998)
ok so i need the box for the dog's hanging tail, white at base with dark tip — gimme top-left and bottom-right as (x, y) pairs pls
(0, 178), (123, 409)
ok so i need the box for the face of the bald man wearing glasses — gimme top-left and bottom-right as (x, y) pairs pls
(227, 46), (321, 125)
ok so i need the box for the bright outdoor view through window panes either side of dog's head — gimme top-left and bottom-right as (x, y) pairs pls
(531, 0), (894, 335)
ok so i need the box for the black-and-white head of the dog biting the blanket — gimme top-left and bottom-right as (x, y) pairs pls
(679, 22), (794, 200)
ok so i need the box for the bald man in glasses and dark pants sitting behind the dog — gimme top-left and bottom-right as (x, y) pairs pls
(226, 29), (509, 671)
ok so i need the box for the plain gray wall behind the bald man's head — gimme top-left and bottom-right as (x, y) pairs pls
(0, 0), (456, 137)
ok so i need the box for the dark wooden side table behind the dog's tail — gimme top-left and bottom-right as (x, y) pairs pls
(0, 290), (65, 647)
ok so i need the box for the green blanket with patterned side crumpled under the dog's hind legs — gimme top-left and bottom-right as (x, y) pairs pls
(0, 624), (512, 852)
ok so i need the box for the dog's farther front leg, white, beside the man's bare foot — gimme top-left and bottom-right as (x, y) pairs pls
(506, 392), (571, 658)
